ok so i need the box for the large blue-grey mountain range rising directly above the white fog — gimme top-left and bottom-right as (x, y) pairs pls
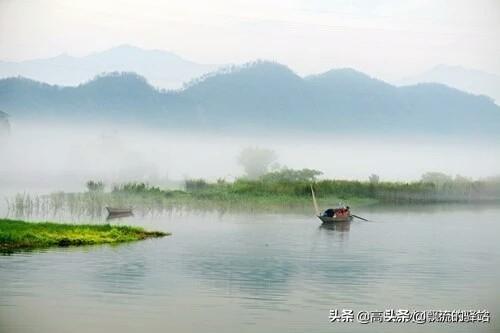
(0, 61), (500, 136)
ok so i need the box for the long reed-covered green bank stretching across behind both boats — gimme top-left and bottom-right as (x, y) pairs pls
(8, 177), (500, 217)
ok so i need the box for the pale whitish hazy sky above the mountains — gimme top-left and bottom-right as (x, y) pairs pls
(0, 0), (500, 80)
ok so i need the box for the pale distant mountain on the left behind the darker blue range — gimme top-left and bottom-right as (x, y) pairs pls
(0, 45), (217, 89)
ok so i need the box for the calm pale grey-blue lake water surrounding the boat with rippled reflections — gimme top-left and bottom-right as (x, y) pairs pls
(0, 206), (500, 333)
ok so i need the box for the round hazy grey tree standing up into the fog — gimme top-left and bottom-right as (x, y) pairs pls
(238, 147), (278, 179)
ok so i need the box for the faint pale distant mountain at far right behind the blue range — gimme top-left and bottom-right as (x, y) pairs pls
(397, 65), (500, 105)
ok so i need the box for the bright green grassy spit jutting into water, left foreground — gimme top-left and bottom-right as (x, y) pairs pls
(0, 219), (169, 251)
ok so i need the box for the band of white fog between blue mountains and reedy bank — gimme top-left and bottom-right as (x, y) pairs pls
(0, 123), (500, 192)
